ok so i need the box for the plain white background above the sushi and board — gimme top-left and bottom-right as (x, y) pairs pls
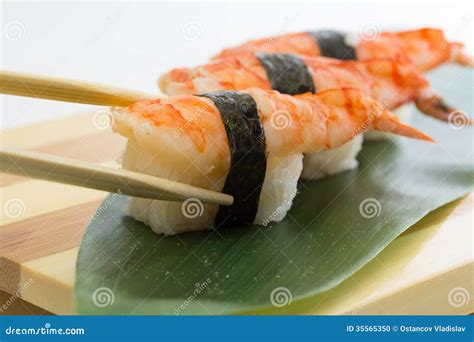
(0, 0), (473, 129)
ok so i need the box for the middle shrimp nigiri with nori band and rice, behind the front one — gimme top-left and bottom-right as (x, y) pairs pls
(158, 52), (454, 179)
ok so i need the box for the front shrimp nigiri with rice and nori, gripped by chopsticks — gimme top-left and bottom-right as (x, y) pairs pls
(112, 88), (431, 234)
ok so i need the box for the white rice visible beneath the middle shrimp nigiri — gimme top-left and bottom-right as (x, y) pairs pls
(301, 135), (363, 180)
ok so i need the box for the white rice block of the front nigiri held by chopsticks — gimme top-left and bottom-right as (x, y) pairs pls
(113, 109), (303, 235)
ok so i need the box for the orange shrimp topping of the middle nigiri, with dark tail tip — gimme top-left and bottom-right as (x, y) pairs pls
(159, 52), (460, 121)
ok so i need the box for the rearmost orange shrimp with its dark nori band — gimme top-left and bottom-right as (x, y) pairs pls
(216, 28), (474, 71)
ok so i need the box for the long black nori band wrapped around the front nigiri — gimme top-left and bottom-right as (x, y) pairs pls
(201, 91), (267, 228)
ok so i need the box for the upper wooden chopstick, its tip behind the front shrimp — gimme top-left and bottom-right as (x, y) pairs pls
(0, 71), (158, 107)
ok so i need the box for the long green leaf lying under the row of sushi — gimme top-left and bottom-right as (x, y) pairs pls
(75, 67), (473, 314)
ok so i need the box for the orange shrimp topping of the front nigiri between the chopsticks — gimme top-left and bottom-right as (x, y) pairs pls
(115, 88), (433, 159)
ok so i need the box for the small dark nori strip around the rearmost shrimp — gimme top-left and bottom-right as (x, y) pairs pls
(308, 30), (357, 60)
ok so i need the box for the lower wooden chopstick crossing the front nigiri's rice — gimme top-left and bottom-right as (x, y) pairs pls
(0, 148), (233, 205)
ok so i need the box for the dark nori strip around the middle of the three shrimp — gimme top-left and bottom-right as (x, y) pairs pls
(256, 53), (316, 95)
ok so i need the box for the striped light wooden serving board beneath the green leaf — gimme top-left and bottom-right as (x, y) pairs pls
(0, 114), (474, 314)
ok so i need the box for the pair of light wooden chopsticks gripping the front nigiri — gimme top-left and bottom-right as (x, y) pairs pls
(0, 71), (233, 205)
